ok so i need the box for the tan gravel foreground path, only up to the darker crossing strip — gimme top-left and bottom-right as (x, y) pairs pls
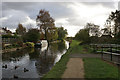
(62, 58), (84, 79)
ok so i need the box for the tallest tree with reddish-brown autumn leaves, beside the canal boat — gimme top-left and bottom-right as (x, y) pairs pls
(36, 10), (55, 40)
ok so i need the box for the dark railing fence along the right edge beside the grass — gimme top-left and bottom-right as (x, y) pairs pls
(90, 44), (120, 65)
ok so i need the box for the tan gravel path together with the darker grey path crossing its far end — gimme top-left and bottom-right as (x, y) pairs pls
(62, 54), (116, 80)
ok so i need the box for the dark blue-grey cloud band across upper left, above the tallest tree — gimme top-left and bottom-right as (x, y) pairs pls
(2, 2), (72, 18)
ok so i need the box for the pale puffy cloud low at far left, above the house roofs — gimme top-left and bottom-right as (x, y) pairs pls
(2, 10), (27, 29)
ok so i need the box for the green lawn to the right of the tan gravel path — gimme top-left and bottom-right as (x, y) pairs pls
(83, 58), (118, 79)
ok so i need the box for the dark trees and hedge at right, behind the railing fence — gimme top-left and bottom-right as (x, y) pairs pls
(74, 10), (120, 44)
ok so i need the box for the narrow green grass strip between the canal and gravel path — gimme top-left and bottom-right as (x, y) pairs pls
(43, 47), (70, 78)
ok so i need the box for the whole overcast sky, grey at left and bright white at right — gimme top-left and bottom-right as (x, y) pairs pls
(0, 1), (118, 36)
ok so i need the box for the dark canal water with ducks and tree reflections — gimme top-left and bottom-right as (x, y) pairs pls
(2, 41), (69, 78)
